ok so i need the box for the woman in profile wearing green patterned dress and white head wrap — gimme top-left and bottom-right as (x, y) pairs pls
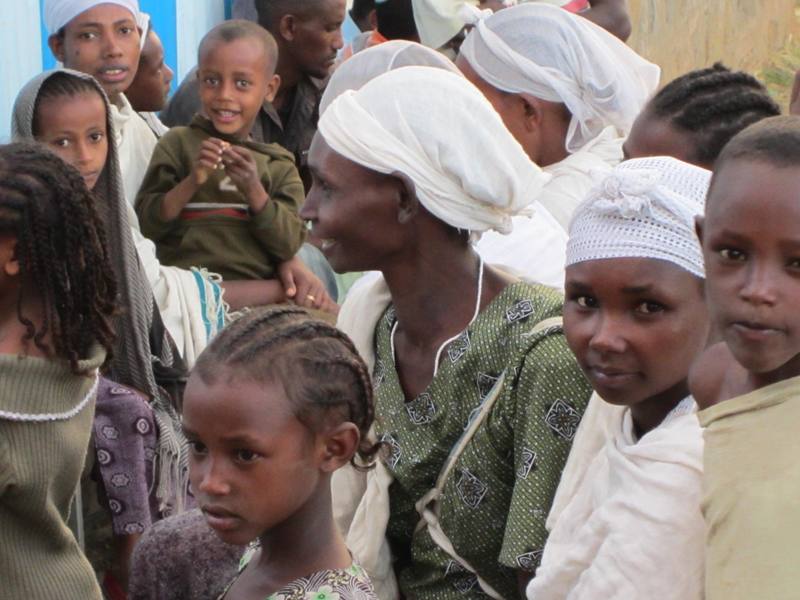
(314, 67), (588, 600)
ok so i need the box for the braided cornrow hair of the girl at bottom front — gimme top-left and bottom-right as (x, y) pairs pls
(194, 306), (381, 469)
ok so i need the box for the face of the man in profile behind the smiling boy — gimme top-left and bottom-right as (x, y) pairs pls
(284, 0), (347, 79)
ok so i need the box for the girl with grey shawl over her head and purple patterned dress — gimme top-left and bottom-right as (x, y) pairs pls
(14, 70), (183, 593)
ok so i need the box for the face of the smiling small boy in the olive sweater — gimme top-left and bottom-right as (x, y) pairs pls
(197, 37), (280, 139)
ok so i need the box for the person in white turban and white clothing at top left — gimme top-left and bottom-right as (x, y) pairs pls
(42, 0), (158, 209)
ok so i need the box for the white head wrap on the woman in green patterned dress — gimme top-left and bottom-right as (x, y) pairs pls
(319, 67), (549, 233)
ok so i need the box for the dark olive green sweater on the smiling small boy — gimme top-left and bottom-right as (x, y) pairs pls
(136, 115), (305, 280)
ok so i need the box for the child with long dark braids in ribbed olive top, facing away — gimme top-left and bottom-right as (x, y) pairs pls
(0, 144), (116, 600)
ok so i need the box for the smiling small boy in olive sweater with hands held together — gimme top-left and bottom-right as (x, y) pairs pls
(136, 20), (304, 279)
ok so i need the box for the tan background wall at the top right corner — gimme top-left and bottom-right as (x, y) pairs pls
(628, 0), (798, 82)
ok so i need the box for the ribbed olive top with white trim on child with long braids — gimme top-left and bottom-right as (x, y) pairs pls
(0, 346), (105, 600)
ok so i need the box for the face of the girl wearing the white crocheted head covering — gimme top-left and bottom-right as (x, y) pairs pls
(564, 258), (708, 418)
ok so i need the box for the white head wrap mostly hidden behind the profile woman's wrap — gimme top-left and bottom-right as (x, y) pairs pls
(319, 40), (461, 114)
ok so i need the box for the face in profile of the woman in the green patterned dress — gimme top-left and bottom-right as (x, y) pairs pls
(300, 134), (407, 273)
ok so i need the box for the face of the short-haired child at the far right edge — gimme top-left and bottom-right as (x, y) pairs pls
(698, 160), (800, 379)
